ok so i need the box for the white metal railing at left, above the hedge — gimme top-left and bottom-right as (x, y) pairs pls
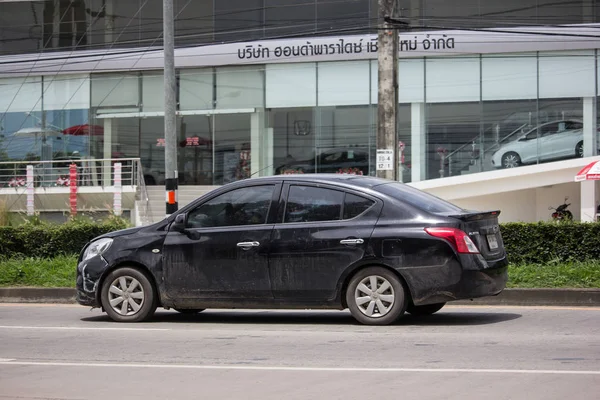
(0, 158), (144, 188)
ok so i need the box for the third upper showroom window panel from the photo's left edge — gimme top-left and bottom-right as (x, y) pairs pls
(92, 73), (139, 107)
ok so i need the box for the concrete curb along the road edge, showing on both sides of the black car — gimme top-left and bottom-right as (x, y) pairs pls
(0, 287), (600, 307)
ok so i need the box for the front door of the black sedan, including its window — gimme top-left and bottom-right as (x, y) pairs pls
(163, 185), (279, 302)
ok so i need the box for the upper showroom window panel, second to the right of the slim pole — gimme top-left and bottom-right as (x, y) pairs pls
(216, 66), (264, 109)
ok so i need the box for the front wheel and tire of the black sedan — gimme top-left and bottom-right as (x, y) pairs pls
(100, 267), (157, 322)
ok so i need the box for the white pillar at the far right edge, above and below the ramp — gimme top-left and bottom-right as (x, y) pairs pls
(581, 97), (598, 222)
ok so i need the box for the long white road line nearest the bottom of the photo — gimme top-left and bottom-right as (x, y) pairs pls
(0, 359), (600, 375)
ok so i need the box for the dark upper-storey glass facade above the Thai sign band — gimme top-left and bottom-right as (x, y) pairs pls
(0, 0), (600, 55)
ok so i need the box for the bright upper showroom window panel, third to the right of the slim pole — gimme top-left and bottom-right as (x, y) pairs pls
(266, 63), (317, 108)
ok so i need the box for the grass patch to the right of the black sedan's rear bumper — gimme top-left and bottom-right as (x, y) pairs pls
(507, 260), (600, 288)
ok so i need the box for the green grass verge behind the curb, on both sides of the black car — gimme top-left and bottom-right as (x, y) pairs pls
(0, 256), (600, 288)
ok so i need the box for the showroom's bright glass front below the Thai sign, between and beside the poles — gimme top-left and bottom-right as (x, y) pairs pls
(0, 50), (599, 185)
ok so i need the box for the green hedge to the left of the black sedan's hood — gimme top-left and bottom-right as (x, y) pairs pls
(0, 218), (128, 258)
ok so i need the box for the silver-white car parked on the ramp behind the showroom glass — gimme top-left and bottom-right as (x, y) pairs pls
(492, 120), (583, 168)
